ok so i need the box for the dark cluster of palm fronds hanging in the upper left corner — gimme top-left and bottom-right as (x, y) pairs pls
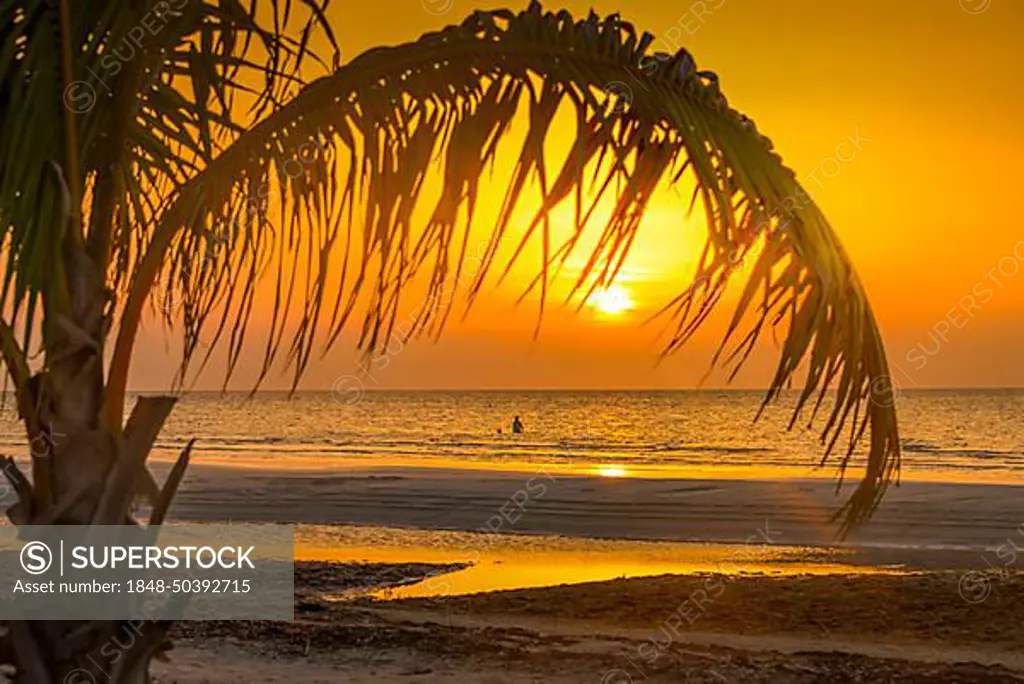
(0, 0), (333, 349)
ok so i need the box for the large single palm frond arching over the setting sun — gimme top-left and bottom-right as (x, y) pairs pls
(110, 2), (900, 529)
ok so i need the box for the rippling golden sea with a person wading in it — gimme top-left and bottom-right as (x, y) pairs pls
(0, 390), (1024, 482)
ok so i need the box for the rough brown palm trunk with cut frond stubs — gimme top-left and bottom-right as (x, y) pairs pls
(0, 215), (182, 684)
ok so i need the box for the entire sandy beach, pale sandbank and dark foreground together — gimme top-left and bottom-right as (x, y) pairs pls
(140, 467), (1024, 684)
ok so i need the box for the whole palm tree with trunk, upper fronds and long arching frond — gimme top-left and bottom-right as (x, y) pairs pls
(0, 0), (899, 683)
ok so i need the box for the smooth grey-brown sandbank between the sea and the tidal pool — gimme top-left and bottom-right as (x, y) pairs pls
(163, 458), (1024, 550)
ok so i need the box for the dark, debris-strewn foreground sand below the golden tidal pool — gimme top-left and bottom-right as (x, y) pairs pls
(151, 563), (1024, 684)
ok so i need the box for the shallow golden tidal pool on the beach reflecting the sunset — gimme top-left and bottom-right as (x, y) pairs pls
(295, 525), (901, 600)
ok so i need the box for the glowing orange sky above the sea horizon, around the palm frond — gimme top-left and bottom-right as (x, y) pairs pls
(132, 0), (1024, 389)
